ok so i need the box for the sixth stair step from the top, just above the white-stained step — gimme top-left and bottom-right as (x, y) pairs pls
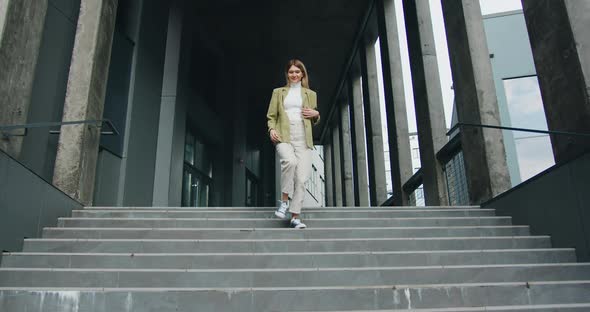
(0, 263), (590, 288)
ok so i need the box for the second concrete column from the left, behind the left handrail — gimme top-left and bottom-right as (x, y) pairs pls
(53, 0), (117, 205)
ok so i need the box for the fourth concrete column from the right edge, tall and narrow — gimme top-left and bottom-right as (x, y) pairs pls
(376, 0), (414, 206)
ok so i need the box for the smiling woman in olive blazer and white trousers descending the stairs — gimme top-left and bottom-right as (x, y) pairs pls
(266, 59), (320, 229)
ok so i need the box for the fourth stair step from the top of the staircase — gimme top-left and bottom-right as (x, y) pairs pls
(23, 236), (551, 253)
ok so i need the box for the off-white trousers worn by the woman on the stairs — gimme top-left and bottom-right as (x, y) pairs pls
(276, 115), (311, 214)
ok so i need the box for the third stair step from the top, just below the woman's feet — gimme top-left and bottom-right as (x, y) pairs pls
(43, 226), (530, 240)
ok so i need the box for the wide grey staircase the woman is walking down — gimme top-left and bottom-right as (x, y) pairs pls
(0, 207), (590, 312)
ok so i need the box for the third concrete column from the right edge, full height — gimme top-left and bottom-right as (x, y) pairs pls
(404, 0), (449, 206)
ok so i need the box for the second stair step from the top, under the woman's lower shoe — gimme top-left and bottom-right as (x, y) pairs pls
(58, 215), (512, 228)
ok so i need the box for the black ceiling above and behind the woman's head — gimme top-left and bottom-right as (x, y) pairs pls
(186, 0), (372, 138)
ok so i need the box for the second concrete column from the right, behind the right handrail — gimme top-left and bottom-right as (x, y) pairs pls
(442, 0), (510, 204)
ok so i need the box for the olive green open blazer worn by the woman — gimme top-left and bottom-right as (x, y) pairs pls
(266, 87), (320, 148)
